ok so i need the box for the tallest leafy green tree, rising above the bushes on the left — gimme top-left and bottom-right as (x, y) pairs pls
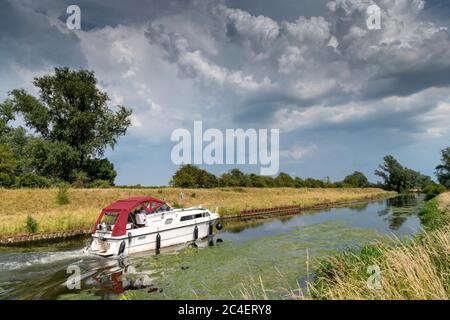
(0, 68), (131, 182)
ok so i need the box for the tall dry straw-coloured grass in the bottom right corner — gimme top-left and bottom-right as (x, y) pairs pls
(311, 227), (450, 300)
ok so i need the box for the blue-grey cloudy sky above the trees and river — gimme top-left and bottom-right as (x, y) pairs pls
(0, 0), (450, 185)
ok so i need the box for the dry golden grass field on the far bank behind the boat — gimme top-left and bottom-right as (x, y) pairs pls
(0, 188), (390, 236)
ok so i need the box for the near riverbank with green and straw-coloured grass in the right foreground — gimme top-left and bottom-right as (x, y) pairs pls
(310, 192), (450, 300)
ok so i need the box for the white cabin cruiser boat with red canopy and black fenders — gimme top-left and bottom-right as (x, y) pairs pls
(87, 197), (222, 257)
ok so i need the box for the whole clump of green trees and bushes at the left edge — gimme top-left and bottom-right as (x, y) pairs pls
(0, 68), (131, 187)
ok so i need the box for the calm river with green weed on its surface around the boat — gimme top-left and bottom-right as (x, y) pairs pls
(0, 195), (423, 299)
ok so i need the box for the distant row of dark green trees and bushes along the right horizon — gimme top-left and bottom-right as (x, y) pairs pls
(170, 148), (450, 196)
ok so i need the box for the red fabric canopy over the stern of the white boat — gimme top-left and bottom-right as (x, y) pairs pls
(92, 197), (165, 236)
